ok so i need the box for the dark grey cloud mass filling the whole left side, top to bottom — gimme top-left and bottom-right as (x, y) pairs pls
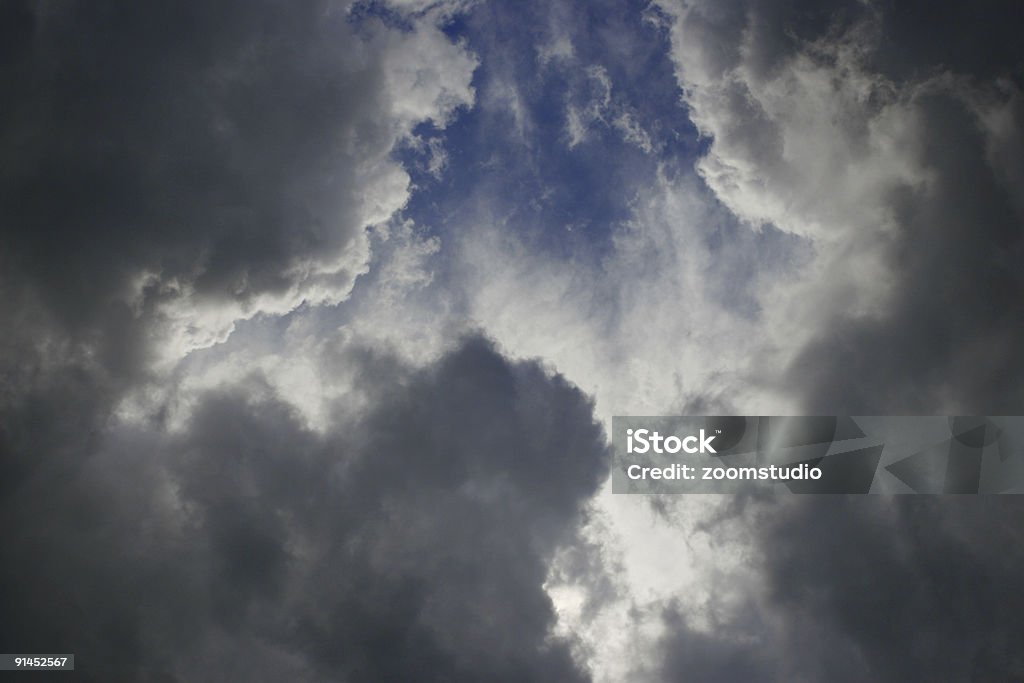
(0, 2), (607, 682)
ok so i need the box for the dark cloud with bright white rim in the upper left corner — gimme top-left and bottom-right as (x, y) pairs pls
(0, 2), (476, 359)
